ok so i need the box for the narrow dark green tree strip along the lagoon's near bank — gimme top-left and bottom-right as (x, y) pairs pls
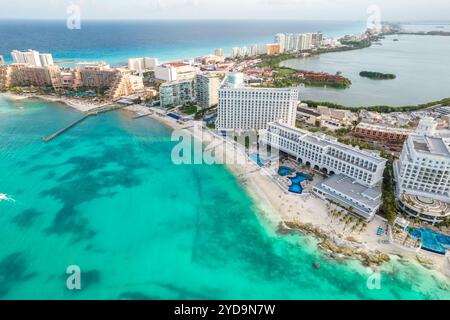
(303, 98), (450, 113)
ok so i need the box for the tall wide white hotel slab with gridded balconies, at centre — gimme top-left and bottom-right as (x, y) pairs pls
(217, 73), (298, 132)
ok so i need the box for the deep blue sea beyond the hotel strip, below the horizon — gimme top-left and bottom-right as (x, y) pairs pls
(0, 20), (365, 65)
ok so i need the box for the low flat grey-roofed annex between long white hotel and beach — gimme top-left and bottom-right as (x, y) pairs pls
(313, 174), (382, 221)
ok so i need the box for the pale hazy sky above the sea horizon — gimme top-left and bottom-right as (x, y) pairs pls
(0, 0), (450, 21)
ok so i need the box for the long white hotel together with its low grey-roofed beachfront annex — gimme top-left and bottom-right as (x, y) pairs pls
(261, 122), (386, 221)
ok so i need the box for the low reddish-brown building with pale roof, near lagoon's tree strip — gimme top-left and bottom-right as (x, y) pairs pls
(355, 122), (414, 144)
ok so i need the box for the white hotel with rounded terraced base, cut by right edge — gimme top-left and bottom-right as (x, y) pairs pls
(394, 118), (450, 224)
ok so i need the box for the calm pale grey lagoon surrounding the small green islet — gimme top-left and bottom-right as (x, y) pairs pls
(282, 35), (450, 107)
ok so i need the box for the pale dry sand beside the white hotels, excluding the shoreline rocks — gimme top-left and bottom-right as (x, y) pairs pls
(137, 111), (450, 276)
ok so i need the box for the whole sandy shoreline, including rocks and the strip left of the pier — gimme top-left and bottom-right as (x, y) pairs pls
(0, 93), (450, 280)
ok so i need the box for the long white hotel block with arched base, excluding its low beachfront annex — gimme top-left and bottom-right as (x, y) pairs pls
(262, 122), (386, 187)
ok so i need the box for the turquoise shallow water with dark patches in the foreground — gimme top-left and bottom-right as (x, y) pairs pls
(0, 98), (450, 299)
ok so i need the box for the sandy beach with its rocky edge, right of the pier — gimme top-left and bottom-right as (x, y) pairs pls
(134, 108), (450, 277)
